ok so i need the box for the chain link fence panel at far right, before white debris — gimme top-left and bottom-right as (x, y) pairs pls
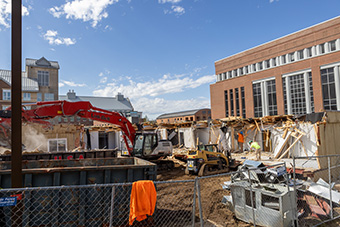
(292, 155), (340, 226)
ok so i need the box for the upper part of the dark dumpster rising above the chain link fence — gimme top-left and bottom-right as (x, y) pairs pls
(0, 157), (157, 188)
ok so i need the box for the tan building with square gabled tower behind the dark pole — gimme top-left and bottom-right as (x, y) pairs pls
(0, 57), (59, 109)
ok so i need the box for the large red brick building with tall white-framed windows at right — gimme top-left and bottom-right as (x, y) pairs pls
(210, 17), (340, 119)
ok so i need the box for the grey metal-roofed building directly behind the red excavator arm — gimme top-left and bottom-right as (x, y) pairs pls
(55, 90), (142, 125)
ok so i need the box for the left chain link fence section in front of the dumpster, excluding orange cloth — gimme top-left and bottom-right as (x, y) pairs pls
(0, 180), (196, 227)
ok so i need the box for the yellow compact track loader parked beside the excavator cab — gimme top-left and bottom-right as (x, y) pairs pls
(185, 144), (235, 176)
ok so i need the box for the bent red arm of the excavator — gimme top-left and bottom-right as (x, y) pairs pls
(16, 101), (136, 156)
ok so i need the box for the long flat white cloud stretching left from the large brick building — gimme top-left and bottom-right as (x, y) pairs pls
(93, 75), (215, 98)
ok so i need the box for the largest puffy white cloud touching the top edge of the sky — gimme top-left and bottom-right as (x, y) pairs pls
(49, 0), (119, 27)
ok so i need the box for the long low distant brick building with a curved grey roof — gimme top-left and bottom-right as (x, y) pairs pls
(156, 108), (211, 124)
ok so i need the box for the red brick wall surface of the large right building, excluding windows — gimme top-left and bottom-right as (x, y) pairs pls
(210, 18), (340, 119)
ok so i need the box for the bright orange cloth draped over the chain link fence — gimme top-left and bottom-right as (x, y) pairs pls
(129, 180), (157, 225)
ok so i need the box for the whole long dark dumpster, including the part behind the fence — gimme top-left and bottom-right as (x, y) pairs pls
(0, 158), (157, 227)
